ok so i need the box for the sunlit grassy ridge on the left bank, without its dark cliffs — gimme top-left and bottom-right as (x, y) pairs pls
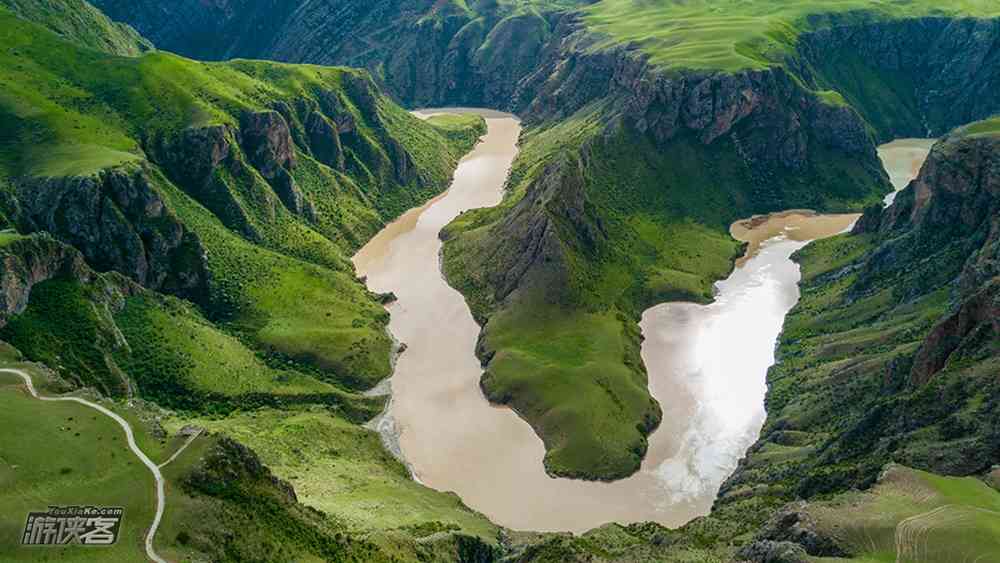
(0, 9), (483, 396)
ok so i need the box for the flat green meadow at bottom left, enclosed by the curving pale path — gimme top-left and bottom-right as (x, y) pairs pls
(0, 368), (155, 562)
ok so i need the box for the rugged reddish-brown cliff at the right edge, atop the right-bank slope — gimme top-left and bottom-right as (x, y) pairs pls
(858, 132), (1000, 385)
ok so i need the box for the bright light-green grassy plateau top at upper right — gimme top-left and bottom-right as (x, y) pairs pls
(583, 0), (1000, 72)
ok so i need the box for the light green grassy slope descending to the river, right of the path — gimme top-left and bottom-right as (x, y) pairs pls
(174, 408), (498, 543)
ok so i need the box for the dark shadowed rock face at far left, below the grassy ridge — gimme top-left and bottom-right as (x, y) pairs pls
(11, 165), (209, 302)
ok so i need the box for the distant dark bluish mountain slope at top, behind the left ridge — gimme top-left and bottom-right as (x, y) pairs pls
(90, 0), (581, 107)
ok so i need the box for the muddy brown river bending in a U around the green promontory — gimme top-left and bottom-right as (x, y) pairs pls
(355, 112), (928, 532)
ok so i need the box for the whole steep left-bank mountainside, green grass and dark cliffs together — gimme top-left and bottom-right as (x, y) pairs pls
(0, 9), (476, 396)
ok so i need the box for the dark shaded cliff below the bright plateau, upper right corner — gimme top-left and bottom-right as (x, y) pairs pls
(790, 17), (1000, 142)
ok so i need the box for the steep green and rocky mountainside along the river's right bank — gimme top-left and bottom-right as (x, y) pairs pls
(717, 122), (1000, 555)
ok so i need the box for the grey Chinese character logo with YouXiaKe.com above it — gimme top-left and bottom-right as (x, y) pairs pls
(21, 506), (124, 545)
